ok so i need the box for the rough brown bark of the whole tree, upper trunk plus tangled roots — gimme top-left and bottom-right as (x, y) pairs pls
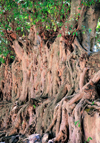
(0, 1), (100, 143)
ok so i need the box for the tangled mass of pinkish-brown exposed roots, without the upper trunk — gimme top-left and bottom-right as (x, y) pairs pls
(0, 21), (100, 143)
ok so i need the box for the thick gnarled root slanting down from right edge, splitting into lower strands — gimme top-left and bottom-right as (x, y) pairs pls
(47, 71), (100, 143)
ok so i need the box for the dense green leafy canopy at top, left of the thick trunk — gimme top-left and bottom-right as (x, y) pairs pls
(0, 0), (70, 30)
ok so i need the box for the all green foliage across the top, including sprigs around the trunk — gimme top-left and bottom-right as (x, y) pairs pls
(0, 0), (100, 62)
